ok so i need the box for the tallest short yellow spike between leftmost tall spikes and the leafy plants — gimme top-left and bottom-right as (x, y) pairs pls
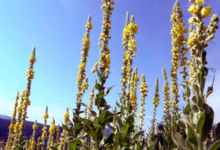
(41, 106), (49, 150)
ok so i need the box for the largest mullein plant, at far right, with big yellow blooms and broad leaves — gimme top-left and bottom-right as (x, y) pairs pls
(173, 0), (220, 150)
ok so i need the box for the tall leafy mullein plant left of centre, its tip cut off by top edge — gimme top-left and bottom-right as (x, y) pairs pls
(80, 0), (117, 150)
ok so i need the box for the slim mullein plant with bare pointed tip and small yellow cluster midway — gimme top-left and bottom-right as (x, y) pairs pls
(146, 78), (160, 150)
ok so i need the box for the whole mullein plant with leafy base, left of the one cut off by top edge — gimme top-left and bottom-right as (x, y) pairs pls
(57, 15), (93, 149)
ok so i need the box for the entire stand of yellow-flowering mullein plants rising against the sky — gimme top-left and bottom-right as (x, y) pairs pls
(1, 0), (220, 150)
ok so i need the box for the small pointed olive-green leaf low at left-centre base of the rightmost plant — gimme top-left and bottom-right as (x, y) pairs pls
(186, 123), (198, 147)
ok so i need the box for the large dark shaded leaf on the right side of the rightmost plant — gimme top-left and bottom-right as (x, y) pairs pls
(196, 103), (214, 142)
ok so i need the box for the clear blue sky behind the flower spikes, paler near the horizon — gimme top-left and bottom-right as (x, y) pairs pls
(0, 0), (220, 132)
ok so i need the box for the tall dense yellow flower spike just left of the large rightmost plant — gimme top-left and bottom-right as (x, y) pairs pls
(170, 1), (188, 124)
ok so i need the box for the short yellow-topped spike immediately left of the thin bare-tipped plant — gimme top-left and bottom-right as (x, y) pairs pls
(138, 74), (148, 131)
